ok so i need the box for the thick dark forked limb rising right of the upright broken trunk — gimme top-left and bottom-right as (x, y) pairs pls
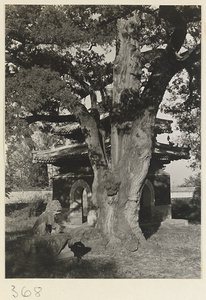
(141, 6), (200, 111)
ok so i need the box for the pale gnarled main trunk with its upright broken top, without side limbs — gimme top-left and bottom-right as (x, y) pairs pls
(93, 16), (155, 251)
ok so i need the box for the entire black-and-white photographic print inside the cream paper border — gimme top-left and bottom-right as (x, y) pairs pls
(3, 1), (203, 288)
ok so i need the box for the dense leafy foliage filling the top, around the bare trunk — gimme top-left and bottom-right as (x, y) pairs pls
(5, 5), (200, 191)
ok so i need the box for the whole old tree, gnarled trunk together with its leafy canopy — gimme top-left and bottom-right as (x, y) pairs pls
(6, 5), (201, 251)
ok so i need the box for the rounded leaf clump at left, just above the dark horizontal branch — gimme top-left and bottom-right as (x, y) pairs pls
(6, 66), (70, 114)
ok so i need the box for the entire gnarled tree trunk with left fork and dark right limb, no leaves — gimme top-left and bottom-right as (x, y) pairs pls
(69, 10), (200, 251)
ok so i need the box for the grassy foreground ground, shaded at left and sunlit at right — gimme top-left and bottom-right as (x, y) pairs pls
(6, 207), (201, 279)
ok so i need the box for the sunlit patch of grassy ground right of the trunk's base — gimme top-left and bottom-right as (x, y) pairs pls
(114, 225), (201, 278)
